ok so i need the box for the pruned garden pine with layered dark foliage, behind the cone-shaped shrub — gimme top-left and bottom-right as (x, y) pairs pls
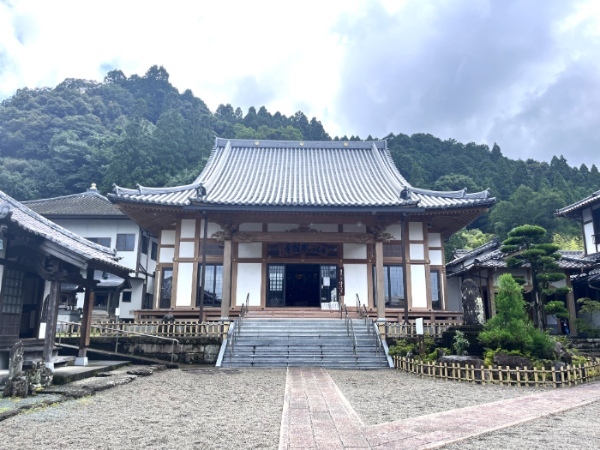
(500, 225), (569, 330)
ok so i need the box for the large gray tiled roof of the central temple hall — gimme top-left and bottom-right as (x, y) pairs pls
(109, 138), (495, 209)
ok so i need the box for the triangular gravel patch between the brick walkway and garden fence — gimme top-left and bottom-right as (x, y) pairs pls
(328, 370), (541, 425)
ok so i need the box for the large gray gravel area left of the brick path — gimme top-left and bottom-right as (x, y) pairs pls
(0, 369), (286, 450)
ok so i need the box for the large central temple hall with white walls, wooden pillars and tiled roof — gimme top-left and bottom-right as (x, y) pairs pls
(108, 138), (495, 321)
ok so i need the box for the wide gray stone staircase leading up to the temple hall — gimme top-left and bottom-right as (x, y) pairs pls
(221, 319), (389, 369)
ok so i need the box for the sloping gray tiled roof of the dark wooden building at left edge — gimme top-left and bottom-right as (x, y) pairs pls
(0, 191), (131, 275)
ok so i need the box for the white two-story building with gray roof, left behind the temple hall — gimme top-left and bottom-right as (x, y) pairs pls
(23, 184), (158, 320)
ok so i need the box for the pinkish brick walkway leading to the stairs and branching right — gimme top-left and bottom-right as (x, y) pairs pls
(279, 367), (600, 450)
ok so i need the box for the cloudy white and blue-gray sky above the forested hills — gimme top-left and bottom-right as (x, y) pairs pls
(0, 0), (600, 167)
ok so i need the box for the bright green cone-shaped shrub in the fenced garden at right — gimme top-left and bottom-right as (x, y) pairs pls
(479, 274), (554, 359)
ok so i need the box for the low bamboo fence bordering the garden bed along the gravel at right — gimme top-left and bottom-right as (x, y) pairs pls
(393, 356), (600, 388)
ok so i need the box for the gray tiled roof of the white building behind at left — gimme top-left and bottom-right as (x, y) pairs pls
(23, 189), (125, 218)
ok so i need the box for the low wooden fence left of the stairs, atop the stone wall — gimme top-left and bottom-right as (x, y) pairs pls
(57, 320), (229, 338)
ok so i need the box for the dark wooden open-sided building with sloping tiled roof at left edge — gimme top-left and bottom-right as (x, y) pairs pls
(0, 191), (129, 370)
